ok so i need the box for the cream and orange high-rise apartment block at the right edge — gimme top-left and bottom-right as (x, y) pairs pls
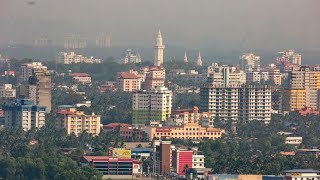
(283, 67), (320, 111)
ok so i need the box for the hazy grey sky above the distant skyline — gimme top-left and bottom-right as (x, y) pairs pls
(0, 0), (320, 50)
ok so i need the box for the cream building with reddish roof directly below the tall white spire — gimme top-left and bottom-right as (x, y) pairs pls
(144, 66), (165, 90)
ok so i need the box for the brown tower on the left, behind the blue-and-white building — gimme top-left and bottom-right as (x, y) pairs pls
(29, 71), (51, 112)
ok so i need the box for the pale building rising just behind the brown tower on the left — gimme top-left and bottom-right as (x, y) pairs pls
(20, 62), (48, 81)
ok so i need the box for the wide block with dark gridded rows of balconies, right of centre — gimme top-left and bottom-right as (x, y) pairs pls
(200, 83), (271, 123)
